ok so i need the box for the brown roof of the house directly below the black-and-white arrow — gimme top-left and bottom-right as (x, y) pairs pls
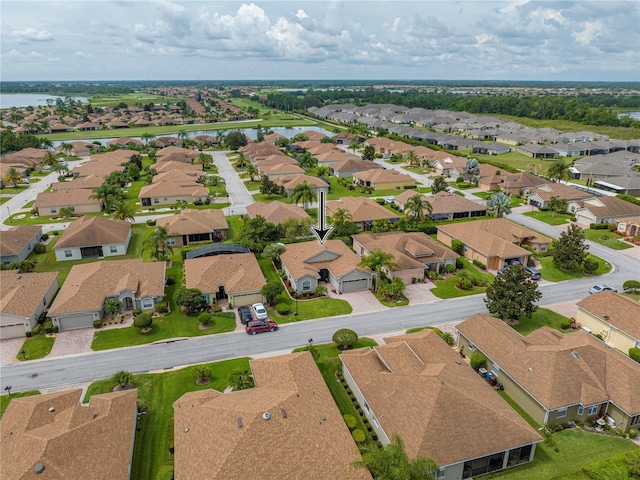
(280, 240), (369, 280)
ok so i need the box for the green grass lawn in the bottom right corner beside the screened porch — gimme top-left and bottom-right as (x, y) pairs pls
(482, 430), (638, 480)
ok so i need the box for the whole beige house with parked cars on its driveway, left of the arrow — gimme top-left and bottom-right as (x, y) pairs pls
(184, 253), (266, 307)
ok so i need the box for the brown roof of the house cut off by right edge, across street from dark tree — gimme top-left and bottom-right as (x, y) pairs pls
(576, 290), (640, 340)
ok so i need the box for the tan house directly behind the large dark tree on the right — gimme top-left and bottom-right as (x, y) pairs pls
(437, 218), (551, 270)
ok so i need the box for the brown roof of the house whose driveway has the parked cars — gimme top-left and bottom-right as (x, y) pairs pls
(184, 253), (266, 293)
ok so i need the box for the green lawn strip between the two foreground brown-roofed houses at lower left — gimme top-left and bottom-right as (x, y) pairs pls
(84, 358), (249, 479)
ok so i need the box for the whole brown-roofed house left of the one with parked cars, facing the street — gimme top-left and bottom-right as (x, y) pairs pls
(49, 259), (166, 331)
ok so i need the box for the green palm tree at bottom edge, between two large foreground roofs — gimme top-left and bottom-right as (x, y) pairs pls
(351, 433), (438, 480)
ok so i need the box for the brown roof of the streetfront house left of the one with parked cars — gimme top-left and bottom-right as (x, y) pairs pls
(49, 259), (165, 316)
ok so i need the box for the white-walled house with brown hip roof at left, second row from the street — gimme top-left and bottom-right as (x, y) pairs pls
(53, 216), (131, 262)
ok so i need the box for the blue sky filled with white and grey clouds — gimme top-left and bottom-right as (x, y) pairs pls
(0, 0), (640, 81)
